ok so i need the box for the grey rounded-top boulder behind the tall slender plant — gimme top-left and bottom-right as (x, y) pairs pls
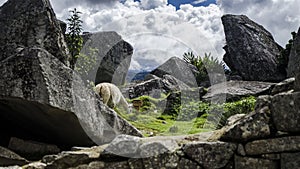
(79, 32), (133, 86)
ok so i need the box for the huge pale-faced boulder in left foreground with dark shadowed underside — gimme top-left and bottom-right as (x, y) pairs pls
(0, 48), (141, 146)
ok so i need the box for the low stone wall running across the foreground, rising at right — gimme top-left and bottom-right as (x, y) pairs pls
(0, 88), (300, 169)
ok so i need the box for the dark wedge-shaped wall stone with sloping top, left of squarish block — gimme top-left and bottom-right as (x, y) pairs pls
(220, 107), (271, 142)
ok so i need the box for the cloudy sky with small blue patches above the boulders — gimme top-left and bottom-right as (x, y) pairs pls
(0, 0), (300, 69)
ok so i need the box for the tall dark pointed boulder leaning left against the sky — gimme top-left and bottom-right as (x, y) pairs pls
(222, 15), (285, 82)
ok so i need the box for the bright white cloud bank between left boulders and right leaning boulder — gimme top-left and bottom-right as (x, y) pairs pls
(47, 0), (224, 69)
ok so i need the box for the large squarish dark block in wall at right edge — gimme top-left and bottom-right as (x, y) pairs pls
(271, 92), (300, 132)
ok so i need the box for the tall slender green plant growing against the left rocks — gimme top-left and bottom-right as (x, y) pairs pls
(66, 8), (83, 69)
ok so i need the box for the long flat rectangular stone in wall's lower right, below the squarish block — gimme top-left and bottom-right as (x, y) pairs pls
(245, 136), (300, 155)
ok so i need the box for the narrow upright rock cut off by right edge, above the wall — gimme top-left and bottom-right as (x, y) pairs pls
(287, 28), (300, 77)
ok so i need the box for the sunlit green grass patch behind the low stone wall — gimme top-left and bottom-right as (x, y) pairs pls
(116, 96), (256, 136)
